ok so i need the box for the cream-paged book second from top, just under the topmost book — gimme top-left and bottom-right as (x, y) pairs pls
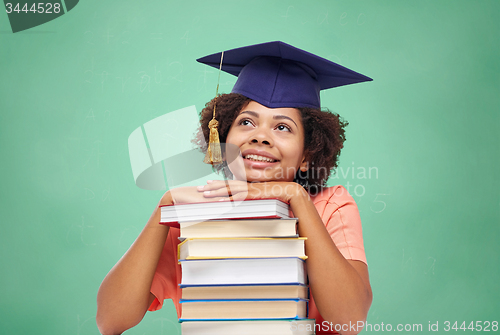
(179, 218), (298, 238)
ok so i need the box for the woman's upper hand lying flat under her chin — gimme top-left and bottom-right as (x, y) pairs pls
(197, 180), (308, 203)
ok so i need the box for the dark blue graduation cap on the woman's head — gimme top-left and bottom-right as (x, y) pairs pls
(197, 41), (372, 108)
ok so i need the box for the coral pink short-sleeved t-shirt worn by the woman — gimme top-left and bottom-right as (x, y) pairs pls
(149, 185), (366, 334)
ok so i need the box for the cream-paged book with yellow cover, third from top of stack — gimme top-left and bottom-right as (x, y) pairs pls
(178, 237), (307, 260)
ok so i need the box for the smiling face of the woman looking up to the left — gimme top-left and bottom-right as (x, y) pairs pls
(226, 101), (307, 182)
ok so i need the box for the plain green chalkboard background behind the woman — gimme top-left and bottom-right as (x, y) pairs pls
(0, 0), (500, 335)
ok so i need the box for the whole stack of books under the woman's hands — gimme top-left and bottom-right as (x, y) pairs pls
(161, 199), (314, 335)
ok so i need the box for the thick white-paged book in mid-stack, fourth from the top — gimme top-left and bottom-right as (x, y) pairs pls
(180, 258), (306, 285)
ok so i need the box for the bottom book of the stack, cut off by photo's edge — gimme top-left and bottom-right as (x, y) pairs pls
(181, 319), (315, 335)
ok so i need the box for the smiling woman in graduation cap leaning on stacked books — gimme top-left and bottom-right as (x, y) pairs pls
(97, 42), (372, 334)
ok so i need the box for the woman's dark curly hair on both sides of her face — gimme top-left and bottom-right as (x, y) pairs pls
(193, 93), (349, 193)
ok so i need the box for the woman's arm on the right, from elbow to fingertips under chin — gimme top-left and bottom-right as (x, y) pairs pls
(199, 181), (372, 334)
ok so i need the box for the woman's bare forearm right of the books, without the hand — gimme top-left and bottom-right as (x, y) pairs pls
(290, 190), (372, 334)
